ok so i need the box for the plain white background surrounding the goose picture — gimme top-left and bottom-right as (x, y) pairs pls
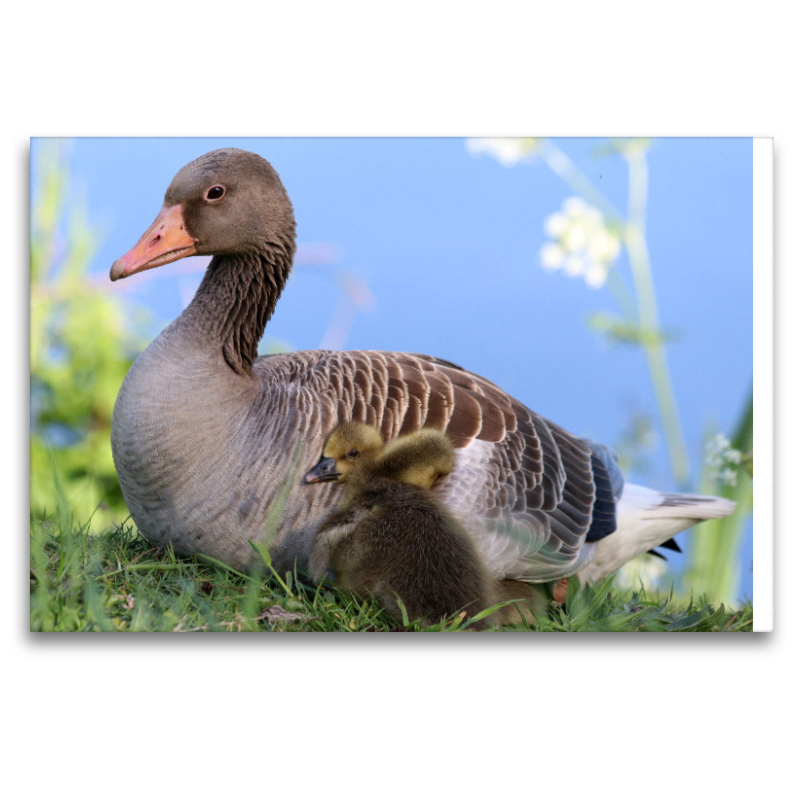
(6, 0), (800, 798)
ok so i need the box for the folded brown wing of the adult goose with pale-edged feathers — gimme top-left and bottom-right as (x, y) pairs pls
(254, 350), (614, 581)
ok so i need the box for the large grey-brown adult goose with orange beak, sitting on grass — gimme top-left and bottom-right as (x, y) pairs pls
(111, 149), (734, 582)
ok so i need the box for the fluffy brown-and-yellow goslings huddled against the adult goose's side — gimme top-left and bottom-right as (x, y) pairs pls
(305, 422), (491, 629)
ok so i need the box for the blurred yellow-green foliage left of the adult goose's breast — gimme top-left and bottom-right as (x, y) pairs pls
(30, 140), (148, 529)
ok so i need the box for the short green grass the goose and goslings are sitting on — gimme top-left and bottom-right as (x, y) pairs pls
(30, 519), (753, 632)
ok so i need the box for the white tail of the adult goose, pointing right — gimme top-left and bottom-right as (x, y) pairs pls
(578, 483), (736, 583)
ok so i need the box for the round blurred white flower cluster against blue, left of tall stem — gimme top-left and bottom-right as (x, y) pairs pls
(540, 197), (621, 289)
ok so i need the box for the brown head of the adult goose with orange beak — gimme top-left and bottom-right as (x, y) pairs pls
(110, 148), (295, 281)
